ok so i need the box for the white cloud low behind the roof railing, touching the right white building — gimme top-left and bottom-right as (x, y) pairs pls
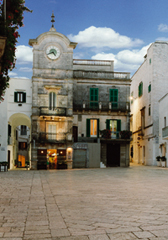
(92, 44), (150, 72)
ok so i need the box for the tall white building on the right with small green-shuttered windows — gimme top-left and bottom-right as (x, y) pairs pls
(131, 41), (168, 165)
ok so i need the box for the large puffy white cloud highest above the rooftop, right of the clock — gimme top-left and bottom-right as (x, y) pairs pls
(68, 26), (143, 48)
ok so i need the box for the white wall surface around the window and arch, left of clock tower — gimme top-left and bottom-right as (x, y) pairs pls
(0, 78), (32, 168)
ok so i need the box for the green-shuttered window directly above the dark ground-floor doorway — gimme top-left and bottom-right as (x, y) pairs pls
(106, 119), (121, 139)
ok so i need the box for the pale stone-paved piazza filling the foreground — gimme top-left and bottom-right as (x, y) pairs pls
(0, 166), (168, 240)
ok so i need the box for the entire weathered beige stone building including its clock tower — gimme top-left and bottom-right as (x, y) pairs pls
(29, 20), (131, 169)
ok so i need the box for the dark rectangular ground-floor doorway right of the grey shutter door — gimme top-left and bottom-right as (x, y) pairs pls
(107, 143), (120, 167)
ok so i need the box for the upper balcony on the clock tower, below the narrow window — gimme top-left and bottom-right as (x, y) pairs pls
(39, 107), (67, 116)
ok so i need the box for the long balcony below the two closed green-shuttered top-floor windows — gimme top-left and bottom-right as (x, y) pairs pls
(73, 101), (130, 112)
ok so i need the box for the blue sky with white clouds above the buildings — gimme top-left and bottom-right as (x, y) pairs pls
(9, 0), (168, 79)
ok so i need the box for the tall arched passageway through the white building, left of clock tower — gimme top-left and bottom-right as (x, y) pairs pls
(8, 113), (31, 169)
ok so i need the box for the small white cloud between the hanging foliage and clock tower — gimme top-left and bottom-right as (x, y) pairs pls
(16, 45), (33, 64)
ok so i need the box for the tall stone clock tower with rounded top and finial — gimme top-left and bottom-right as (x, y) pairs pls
(29, 14), (77, 169)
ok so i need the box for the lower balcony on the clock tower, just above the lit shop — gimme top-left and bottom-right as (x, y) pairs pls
(39, 132), (66, 143)
